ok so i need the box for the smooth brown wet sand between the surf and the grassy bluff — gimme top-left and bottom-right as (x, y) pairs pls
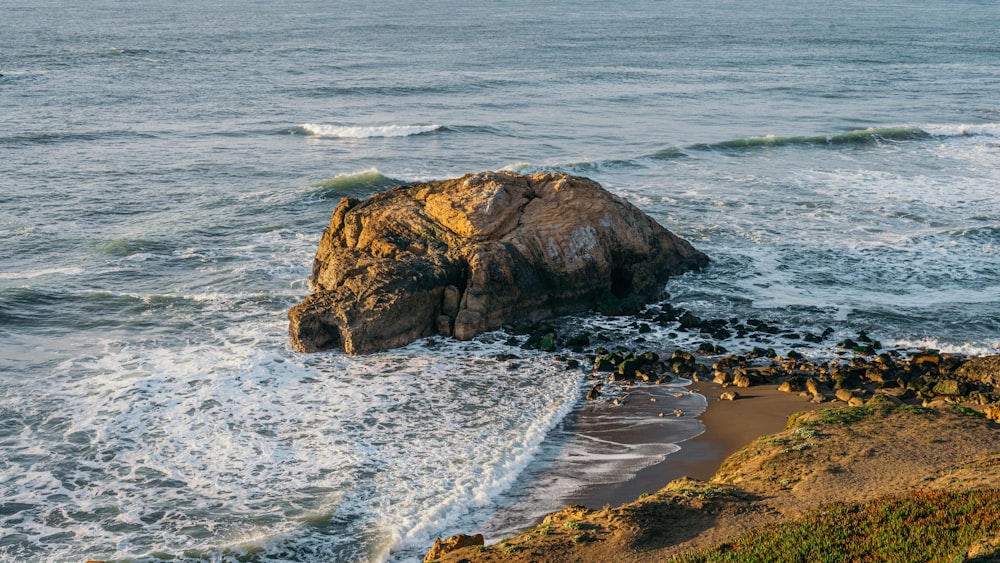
(570, 382), (829, 509)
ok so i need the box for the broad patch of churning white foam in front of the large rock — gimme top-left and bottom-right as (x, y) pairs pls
(0, 318), (581, 559)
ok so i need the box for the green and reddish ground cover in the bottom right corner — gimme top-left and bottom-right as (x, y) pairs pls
(674, 489), (1000, 563)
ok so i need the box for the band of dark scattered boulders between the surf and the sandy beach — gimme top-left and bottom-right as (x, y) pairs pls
(500, 318), (1000, 421)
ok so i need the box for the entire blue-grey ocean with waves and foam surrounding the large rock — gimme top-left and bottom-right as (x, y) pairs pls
(0, 0), (1000, 562)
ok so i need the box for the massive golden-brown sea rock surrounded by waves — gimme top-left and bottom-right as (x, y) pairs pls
(288, 172), (708, 354)
